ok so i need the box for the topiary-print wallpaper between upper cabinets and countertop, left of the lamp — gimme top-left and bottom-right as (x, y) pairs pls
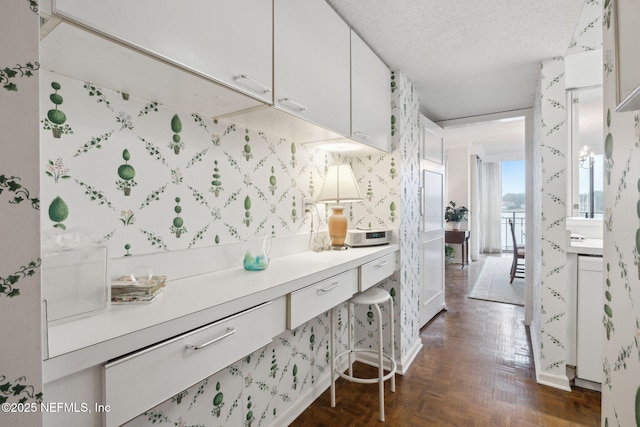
(40, 70), (336, 257)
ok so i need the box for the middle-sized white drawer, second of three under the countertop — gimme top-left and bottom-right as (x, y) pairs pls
(287, 268), (358, 329)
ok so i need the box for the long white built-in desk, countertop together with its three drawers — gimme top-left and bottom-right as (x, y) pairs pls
(43, 236), (399, 426)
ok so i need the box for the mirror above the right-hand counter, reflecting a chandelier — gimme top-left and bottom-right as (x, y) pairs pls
(568, 86), (604, 218)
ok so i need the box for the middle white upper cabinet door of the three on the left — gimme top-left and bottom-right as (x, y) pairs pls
(273, 0), (351, 135)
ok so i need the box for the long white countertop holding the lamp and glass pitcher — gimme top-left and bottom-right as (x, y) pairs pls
(44, 244), (399, 382)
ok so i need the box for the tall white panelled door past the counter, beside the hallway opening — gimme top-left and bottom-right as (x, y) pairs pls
(420, 115), (446, 327)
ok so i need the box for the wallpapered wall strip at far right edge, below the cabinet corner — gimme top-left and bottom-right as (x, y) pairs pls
(602, 0), (640, 426)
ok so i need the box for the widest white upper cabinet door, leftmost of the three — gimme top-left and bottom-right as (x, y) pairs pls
(55, 0), (272, 103)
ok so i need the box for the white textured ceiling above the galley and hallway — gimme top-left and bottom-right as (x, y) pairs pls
(327, 0), (585, 121)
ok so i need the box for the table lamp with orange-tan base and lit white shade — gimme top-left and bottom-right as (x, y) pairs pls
(316, 163), (362, 249)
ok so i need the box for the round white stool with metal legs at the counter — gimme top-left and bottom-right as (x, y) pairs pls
(330, 288), (396, 421)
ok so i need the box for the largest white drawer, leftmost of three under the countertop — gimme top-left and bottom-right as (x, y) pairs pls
(103, 302), (273, 427)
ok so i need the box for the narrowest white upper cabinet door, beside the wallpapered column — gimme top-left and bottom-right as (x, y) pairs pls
(351, 31), (391, 152)
